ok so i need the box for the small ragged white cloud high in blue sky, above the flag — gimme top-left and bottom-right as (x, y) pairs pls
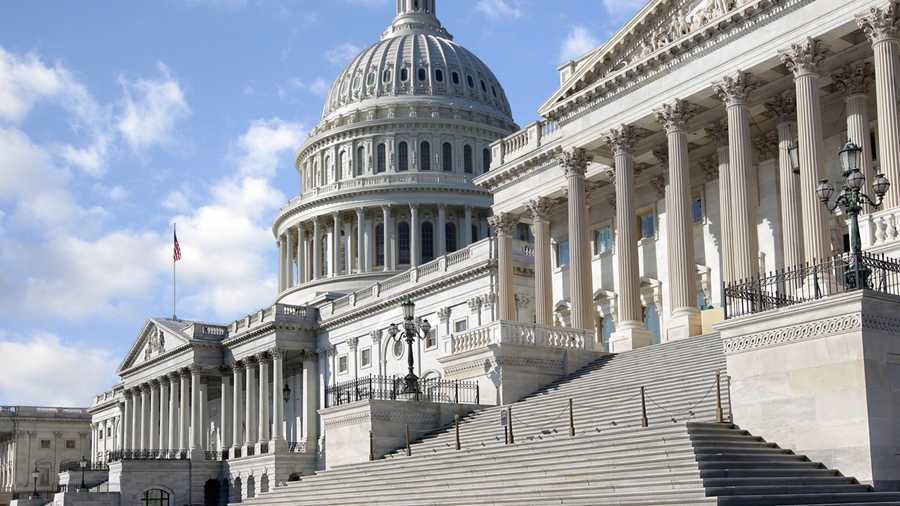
(117, 63), (191, 151)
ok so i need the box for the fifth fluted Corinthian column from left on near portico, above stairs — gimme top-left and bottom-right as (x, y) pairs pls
(656, 100), (701, 341)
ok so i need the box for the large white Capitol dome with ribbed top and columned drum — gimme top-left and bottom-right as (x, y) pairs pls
(272, 0), (518, 304)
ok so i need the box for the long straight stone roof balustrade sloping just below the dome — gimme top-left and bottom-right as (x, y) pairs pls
(322, 237), (494, 319)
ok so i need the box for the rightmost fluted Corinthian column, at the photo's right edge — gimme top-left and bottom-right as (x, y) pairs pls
(856, 2), (900, 207)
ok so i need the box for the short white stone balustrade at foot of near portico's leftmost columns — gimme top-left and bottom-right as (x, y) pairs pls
(450, 321), (592, 353)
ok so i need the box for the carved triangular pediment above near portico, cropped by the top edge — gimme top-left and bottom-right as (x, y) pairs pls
(538, 0), (759, 117)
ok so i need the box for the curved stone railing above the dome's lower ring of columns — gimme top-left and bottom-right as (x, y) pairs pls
(279, 172), (475, 215)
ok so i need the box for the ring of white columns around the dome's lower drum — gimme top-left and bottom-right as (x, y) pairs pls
(278, 204), (475, 291)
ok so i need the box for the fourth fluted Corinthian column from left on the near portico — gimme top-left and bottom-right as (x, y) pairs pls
(604, 125), (653, 353)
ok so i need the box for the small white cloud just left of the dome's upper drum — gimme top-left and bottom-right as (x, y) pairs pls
(237, 118), (306, 177)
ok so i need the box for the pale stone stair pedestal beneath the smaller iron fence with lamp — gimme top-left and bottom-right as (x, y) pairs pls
(319, 400), (478, 469)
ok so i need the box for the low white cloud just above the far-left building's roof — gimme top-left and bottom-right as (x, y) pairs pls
(0, 331), (116, 407)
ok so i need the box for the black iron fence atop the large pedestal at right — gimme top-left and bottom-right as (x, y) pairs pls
(723, 253), (900, 319)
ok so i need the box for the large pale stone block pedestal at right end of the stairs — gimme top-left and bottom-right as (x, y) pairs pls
(716, 291), (900, 490)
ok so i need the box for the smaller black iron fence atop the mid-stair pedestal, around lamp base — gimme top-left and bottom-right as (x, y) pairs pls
(325, 376), (481, 407)
